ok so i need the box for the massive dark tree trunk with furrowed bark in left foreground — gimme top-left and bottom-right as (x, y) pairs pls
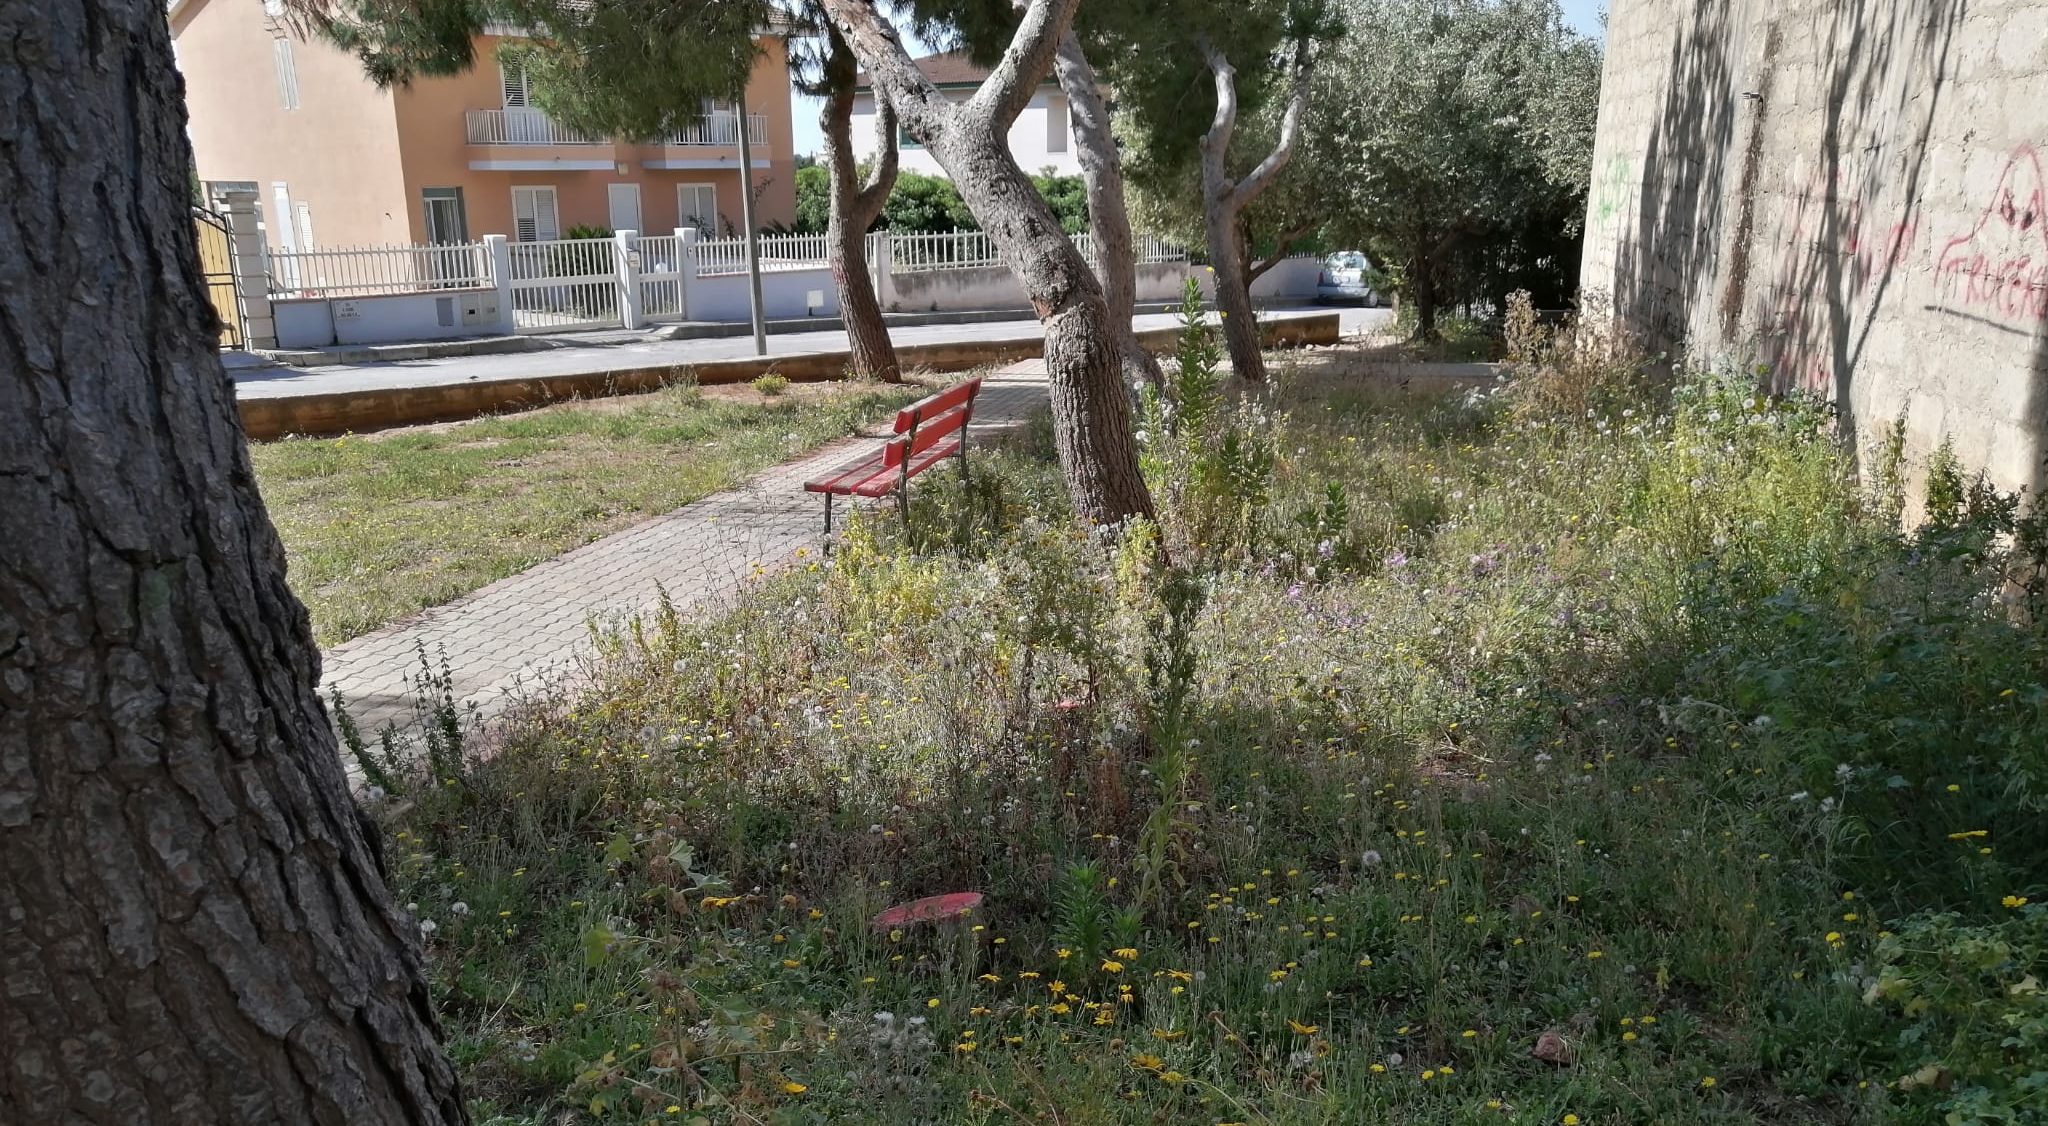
(0, 0), (465, 1126)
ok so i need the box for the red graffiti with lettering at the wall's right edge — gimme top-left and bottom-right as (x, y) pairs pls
(1935, 145), (2048, 321)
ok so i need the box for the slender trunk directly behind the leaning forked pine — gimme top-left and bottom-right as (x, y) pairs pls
(1053, 27), (1165, 387)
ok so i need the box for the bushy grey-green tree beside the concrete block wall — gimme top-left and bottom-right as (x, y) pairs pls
(1296, 0), (1599, 332)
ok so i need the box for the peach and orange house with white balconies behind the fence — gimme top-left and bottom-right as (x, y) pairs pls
(170, 0), (797, 250)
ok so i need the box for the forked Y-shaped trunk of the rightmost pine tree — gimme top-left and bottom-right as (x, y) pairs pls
(1202, 39), (1315, 383)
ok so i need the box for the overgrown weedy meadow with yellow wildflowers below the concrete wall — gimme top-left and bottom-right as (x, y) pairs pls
(352, 317), (2048, 1126)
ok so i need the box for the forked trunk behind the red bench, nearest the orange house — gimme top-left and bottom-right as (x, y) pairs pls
(823, 25), (903, 383)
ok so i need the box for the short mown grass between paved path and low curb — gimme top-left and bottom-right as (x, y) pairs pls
(250, 383), (924, 645)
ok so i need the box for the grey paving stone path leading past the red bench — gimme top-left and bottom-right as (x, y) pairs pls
(319, 360), (1047, 735)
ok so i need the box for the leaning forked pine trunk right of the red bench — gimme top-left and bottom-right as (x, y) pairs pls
(823, 0), (1153, 526)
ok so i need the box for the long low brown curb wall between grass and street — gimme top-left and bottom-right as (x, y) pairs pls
(238, 313), (1339, 442)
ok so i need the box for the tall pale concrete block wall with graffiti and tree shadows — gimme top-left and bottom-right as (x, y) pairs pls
(1583, 0), (2048, 493)
